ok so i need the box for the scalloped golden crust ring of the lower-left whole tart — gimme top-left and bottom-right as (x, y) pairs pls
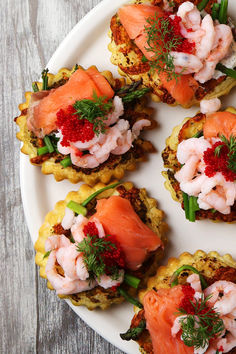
(35, 182), (167, 310)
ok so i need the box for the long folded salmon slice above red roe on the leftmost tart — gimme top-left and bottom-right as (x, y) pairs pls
(27, 68), (114, 137)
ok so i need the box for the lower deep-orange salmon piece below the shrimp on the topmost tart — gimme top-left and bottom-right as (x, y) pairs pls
(159, 72), (198, 105)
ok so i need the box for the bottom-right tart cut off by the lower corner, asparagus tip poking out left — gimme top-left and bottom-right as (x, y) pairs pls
(121, 251), (236, 354)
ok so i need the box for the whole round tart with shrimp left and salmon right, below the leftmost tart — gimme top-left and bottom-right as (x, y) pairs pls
(35, 182), (167, 310)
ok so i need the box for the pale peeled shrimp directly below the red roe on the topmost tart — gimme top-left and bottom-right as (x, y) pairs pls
(170, 52), (203, 75)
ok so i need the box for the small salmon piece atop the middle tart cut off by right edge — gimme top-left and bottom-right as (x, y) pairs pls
(203, 112), (236, 139)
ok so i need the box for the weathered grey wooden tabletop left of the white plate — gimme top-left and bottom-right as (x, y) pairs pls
(0, 0), (121, 354)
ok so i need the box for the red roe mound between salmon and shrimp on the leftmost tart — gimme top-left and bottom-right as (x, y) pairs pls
(56, 106), (94, 146)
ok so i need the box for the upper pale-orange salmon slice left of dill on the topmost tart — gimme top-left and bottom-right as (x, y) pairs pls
(118, 4), (163, 40)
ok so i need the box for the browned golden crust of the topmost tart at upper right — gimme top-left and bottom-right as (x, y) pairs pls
(108, 0), (236, 108)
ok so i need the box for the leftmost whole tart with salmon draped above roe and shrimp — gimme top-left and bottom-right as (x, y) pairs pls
(16, 66), (156, 184)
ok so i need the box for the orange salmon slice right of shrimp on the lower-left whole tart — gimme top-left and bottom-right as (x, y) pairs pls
(91, 196), (162, 270)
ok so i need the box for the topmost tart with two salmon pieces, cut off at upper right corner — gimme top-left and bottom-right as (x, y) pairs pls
(108, 0), (236, 108)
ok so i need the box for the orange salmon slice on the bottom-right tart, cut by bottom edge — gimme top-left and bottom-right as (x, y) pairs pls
(143, 285), (194, 354)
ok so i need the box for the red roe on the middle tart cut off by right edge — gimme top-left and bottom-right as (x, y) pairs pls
(203, 141), (236, 182)
